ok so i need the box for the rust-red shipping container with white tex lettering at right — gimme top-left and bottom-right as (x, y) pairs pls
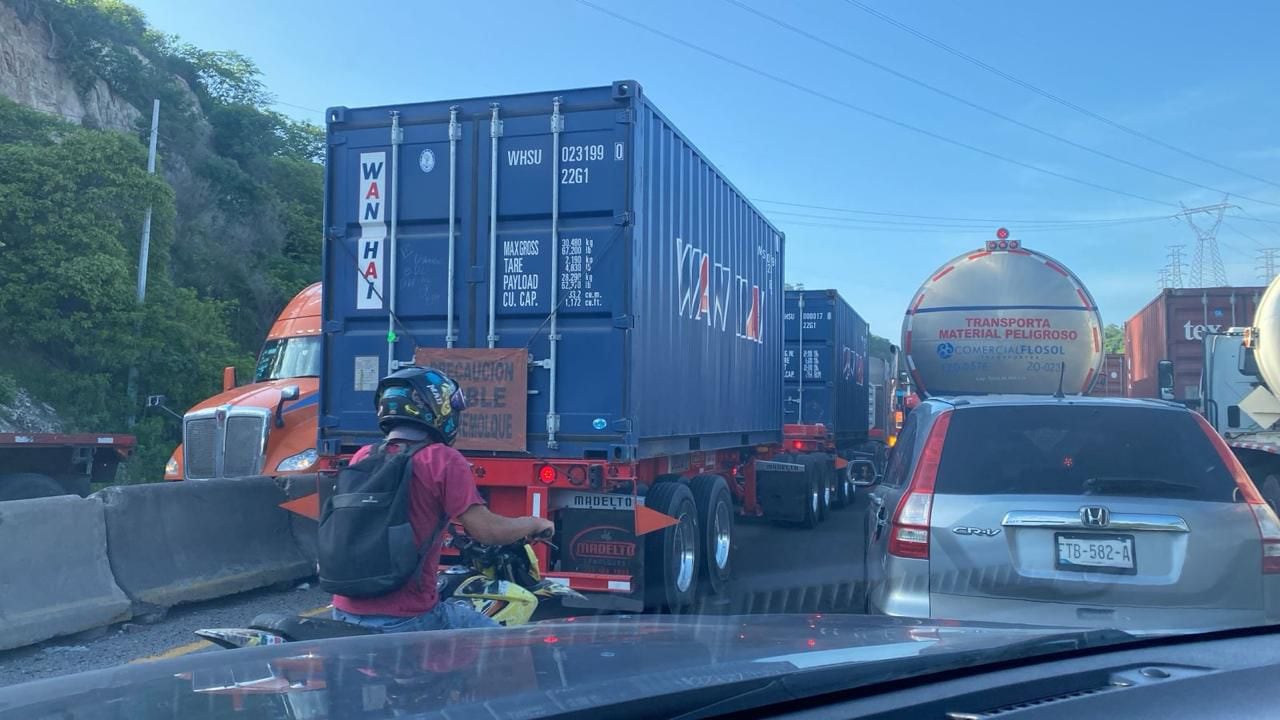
(1124, 287), (1266, 404)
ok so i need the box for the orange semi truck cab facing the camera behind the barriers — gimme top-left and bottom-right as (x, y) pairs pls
(164, 283), (321, 480)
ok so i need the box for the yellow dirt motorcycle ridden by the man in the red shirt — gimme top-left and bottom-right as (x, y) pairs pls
(196, 533), (585, 650)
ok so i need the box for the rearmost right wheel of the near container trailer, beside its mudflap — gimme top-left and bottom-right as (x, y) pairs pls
(644, 483), (701, 610)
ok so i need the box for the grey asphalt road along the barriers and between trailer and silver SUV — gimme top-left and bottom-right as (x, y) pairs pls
(0, 496), (865, 687)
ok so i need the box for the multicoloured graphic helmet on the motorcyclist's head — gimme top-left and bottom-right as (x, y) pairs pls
(374, 366), (467, 445)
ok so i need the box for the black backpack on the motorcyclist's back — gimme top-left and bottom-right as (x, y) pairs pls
(317, 441), (445, 597)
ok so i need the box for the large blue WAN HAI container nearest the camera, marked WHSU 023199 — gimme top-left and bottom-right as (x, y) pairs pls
(320, 81), (783, 460)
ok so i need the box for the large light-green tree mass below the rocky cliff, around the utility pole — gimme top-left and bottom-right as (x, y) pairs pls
(0, 99), (244, 478)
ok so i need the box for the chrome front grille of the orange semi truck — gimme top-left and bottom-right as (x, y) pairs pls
(182, 411), (268, 480)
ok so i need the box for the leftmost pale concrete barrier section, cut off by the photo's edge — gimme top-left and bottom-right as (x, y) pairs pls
(0, 496), (131, 650)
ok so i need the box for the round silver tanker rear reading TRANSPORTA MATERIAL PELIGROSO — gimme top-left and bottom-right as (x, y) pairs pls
(902, 241), (1103, 395)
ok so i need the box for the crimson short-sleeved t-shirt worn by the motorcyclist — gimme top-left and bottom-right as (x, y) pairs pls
(333, 443), (484, 618)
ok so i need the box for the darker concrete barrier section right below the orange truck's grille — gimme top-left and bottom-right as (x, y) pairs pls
(97, 477), (315, 614)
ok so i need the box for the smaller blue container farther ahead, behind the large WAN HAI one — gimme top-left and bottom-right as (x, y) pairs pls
(782, 290), (870, 448)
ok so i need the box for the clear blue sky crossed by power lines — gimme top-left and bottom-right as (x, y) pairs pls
(133, 0), (1280, 340)
